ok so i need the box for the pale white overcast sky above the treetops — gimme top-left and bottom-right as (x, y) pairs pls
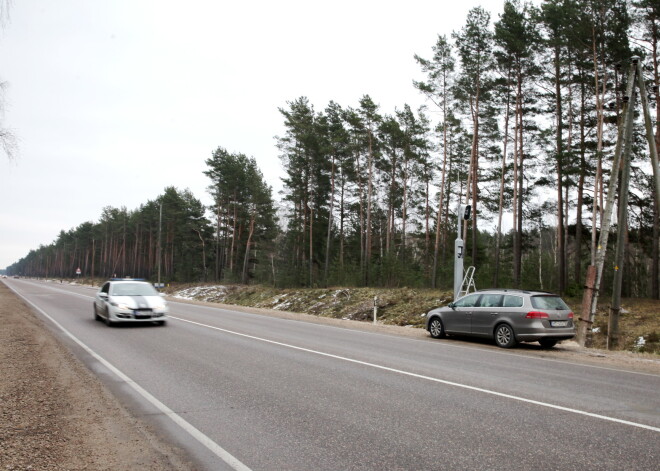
(0, 0), (510, 268)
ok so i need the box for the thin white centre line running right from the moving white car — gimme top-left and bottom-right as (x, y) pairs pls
(169, 316), (660, 432)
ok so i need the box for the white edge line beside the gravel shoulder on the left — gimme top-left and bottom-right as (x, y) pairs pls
(14, 291), (251, 471)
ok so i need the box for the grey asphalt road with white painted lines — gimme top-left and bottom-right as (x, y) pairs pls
(5, 280), (660, 470)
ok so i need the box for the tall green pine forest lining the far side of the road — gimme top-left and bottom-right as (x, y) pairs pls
(8, 0), (660, 299)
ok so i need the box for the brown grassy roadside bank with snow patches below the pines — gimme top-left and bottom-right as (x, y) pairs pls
(169, 284), (660, 354)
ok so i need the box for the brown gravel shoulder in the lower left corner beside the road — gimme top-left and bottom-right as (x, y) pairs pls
(0, 283), (192, 471)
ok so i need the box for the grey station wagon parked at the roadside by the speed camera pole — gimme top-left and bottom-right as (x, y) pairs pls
(426, 289), (575, 348)
